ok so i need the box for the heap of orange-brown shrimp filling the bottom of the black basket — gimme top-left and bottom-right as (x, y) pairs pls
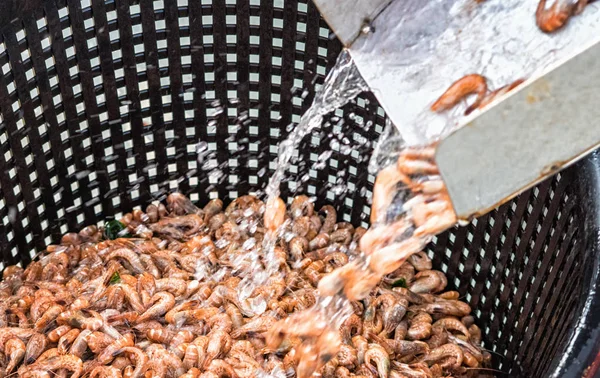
(0, 193), (490, 378)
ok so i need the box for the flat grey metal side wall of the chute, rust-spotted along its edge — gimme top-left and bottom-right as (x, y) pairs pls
(436, 37), (600, 219)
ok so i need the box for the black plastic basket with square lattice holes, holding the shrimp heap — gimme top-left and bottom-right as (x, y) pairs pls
(0, 0), (600, 377)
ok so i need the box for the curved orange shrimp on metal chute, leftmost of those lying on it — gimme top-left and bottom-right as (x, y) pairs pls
(431, 74), (488, 114)
